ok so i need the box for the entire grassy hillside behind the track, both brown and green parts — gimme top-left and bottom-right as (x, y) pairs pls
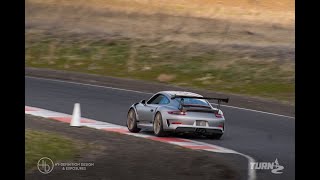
(25, 0), (295, 104)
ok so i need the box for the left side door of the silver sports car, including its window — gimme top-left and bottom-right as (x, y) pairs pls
(138, 94), (165, 123)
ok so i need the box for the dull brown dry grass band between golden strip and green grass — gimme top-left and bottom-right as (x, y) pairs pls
(26, 0), (295, 54)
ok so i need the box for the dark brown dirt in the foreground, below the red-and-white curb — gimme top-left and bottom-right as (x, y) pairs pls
(25, 115), (246, 180)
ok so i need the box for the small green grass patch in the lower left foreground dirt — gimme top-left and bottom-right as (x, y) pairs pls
(25, 129), (89, 171)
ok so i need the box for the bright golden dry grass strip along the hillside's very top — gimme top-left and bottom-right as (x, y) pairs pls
(28, 0), (295, 25)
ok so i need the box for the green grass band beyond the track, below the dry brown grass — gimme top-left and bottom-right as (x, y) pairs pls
(25, 31), (295, 104)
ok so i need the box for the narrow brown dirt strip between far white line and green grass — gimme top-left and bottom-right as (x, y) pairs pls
(25, 67), (295, 117)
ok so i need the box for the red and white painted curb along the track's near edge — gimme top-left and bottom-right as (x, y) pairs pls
(25, 106), (256, 180)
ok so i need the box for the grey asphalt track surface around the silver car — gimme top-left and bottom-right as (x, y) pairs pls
(25, 77), (295, 180)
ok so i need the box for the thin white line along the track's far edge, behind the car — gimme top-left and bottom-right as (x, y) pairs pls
(25, 76), (295, 119)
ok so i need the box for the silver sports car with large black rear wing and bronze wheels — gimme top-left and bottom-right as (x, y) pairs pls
(127, 91), (229, 139)
